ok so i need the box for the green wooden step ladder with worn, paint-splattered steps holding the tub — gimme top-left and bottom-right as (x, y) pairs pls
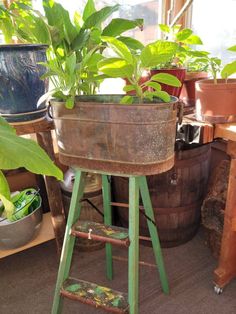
(52, 169), (169, 314)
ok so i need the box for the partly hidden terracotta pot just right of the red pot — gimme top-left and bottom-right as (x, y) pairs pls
(180, 72), (208, 106)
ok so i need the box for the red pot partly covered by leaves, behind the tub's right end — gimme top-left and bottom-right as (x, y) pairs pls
(151, 68), (186, 97)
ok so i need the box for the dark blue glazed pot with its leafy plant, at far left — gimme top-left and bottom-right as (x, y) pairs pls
(0, 0), (48, 122)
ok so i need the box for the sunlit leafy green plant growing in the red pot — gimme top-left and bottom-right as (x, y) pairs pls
(158, 24), (202, 68)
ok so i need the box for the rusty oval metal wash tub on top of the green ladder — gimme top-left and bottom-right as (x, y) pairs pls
(51, 95), (177, 175)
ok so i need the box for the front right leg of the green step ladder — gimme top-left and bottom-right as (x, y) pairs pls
(128, 177), (139, 314)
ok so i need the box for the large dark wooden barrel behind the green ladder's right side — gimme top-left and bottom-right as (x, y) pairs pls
(113, 145), (211, 247)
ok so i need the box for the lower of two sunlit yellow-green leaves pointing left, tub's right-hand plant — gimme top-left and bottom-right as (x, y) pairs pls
(98, 58), (134, 78)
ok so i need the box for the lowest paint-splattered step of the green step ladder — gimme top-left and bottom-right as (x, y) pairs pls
(60, 278), (129, 313)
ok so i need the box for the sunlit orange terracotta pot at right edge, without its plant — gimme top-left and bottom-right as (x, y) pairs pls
(196, 79), (236, 123)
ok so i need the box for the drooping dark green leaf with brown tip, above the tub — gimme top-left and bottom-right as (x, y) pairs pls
(102, 18), (143, 37)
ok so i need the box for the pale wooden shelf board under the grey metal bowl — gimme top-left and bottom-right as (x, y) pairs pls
(0, 213), (55, 259)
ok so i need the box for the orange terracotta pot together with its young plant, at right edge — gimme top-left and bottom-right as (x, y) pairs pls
(196, 46), (236, 123)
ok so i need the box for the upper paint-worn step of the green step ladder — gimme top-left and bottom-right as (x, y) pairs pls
(71, 221), (130, 246)
